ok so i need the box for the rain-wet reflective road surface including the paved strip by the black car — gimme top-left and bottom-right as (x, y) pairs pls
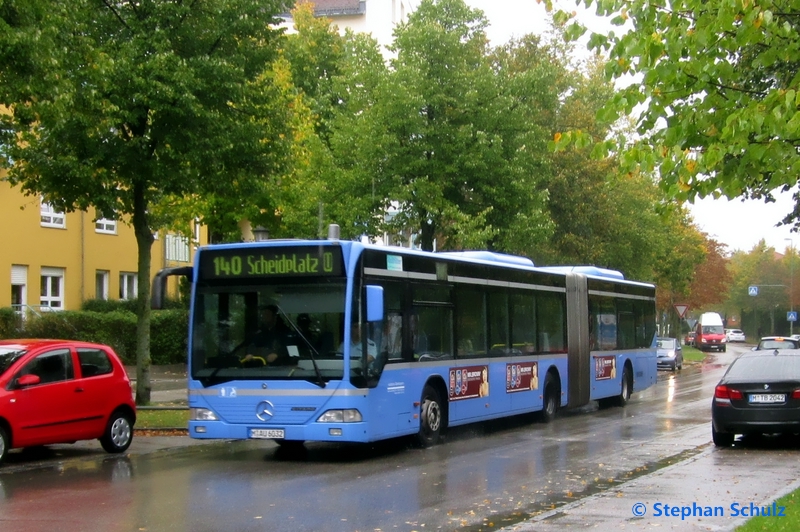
(0, 346), (800, 532)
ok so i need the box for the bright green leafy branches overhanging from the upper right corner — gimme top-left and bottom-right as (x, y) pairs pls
(547, 0), (800, 223)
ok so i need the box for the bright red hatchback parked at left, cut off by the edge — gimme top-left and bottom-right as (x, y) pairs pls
(0, 340), (136, 464)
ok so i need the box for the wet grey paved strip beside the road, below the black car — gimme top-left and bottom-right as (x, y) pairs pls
(502, 426), (800, 532)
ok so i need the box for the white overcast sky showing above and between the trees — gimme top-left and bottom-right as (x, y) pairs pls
(465, 0), (800, 252)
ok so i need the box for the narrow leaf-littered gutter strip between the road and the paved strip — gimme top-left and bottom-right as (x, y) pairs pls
(455, 443), (711, 532)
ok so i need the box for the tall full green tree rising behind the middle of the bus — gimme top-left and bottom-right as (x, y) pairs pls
(331, 0), (550, 250)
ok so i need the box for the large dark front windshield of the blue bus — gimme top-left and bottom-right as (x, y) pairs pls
(190, 277), (345, 386)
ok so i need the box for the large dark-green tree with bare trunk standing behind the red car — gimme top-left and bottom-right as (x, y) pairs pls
(0, 0), (289, 404)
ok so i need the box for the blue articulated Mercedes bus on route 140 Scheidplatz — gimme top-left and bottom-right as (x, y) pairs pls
(153, 231), (656, 446)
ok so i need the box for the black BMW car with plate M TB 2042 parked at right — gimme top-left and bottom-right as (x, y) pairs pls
(711, 349), (800, 447)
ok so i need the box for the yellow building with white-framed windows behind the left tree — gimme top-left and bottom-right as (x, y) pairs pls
(0, 177), (202, 311)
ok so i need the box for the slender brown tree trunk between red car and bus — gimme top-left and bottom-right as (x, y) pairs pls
(133, 184), (153, 405)
